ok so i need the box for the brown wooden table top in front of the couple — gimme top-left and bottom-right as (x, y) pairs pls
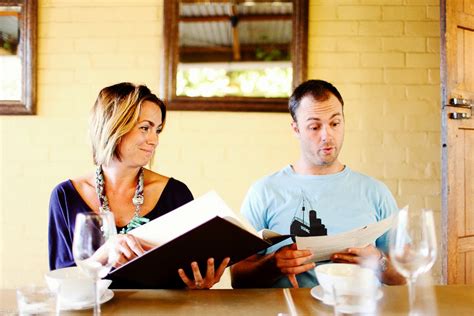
(0, 285), (474, 316)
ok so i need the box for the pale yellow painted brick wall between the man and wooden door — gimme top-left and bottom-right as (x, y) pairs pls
(309, 0), (441, 281)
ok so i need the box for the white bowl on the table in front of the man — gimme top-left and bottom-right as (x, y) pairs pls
(314, 263), (379, 297)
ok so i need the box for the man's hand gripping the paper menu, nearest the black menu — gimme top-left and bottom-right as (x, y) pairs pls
(275, 244), (315, 288)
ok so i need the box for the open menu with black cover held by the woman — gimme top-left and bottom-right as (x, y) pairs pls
(107, 191), (290, 289)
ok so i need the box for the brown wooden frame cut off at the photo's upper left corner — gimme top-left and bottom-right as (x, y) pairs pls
(0, 0), (38, 115)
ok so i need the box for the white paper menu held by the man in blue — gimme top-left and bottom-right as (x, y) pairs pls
(296, 215), (395, 262)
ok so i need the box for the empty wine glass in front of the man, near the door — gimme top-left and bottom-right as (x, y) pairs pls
(389, 207), (437, 311)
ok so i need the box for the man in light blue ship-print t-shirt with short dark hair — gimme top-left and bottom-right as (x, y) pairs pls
(231, 80), (404, 288)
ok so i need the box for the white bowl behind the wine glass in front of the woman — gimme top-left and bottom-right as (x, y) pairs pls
(45, 267), (112, 304)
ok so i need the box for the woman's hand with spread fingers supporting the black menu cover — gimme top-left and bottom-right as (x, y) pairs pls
(178, 258), (230, 290)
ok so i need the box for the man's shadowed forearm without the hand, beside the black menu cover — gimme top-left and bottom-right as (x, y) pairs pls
(230, 253), (282, 288)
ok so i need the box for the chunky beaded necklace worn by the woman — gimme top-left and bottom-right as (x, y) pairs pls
(95, 165), (150, 234)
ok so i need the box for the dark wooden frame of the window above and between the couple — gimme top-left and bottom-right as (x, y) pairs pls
(162, 0), (308, 112)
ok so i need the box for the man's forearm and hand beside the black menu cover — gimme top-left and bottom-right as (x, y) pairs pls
(230, 244), (315, 288)
